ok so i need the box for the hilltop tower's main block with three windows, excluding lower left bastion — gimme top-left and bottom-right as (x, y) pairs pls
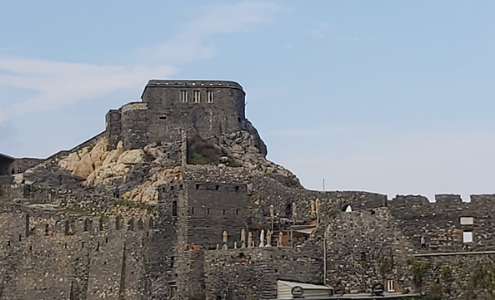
(142, 81), (245, 142)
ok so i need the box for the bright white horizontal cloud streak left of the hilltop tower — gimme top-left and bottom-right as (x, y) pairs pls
(0, 59), (175, 117)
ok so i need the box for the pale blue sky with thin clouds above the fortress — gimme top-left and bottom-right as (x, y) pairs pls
(0, 0), (495, 200)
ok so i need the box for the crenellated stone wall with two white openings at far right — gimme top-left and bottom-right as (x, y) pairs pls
(388, 195), (495, 251)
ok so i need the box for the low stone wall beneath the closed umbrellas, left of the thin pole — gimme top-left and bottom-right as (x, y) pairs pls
(205, 244), (323, 300)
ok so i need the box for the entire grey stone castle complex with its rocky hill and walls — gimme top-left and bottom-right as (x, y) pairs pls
(0, 80), (495, 300)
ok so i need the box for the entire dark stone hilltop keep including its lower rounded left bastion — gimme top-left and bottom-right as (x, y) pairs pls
(106, 80), (252, 153)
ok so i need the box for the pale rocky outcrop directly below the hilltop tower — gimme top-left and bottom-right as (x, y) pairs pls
(24, 127), (301, 204)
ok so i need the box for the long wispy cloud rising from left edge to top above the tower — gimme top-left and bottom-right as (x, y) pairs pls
(0, 1), (283, 122)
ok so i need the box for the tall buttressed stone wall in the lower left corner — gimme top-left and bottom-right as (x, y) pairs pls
(0, 206), (149, 300)
